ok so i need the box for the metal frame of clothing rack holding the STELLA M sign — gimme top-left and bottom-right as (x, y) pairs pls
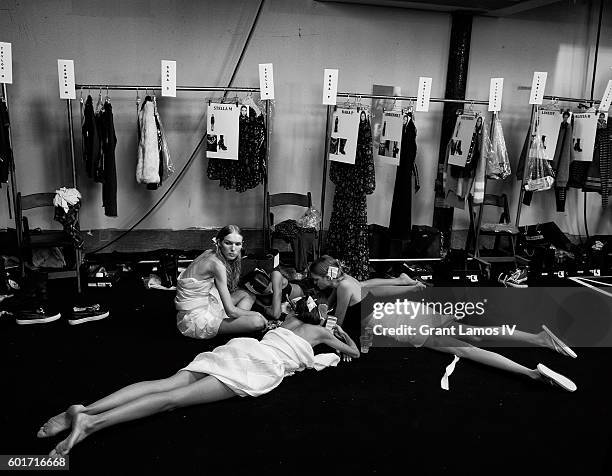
(66, 84), (270, 255)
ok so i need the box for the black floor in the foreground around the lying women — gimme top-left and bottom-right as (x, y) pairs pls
(0, 284), (612, 475)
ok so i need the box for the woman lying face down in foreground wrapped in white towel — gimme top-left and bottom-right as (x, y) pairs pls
(37, 299), (359, 457)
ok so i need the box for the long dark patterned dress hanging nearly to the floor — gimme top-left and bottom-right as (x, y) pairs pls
(327, 114), (376, 280)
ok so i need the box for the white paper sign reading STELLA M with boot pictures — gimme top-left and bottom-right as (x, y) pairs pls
(206, 103), (239, 160)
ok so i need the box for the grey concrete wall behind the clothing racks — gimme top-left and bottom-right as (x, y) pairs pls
(0, 0), (612, 238)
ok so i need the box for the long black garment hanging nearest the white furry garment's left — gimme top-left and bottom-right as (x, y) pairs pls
(98, 100), (117, 217)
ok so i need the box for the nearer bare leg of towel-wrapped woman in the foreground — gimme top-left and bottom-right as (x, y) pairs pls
(49, 375), (236, 457)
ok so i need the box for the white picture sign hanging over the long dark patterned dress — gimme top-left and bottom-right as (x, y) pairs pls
(329, 108), (360, 164)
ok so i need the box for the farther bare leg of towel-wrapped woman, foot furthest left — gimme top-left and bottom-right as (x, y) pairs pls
(37, 371), (204, 438)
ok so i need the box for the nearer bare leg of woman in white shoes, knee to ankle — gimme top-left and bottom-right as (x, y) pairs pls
(424, 336), (541, 379)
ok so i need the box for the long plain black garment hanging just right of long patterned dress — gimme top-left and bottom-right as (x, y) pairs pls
(389, 117), (419, 239)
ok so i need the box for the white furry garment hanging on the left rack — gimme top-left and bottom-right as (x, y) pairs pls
(136, 96), (160, 184)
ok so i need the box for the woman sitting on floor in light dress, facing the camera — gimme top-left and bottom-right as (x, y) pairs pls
(174, 225), (267, 339)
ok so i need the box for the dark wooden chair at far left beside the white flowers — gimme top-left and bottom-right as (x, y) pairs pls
(15, 193), (82, 293)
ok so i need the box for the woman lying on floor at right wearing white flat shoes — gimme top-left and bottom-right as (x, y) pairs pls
(310, 256), (576, 392)
